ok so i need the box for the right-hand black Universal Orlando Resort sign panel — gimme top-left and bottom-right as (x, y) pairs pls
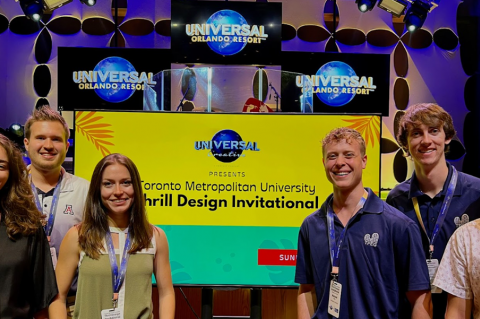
(282, 52), (390, 116)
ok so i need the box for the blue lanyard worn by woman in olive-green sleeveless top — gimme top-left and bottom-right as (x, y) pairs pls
(106, 230), (132, 308)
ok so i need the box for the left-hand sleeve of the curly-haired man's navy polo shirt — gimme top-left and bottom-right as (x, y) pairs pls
(295, 219), (314, 284)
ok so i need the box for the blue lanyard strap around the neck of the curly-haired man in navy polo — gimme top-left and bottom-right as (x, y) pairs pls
(327, 192), (368, 280)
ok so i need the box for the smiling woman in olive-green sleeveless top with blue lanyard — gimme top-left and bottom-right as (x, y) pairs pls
(49, 154), (175, 319)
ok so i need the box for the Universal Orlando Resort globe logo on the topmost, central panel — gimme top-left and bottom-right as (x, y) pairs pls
(185, 10), (268, 55)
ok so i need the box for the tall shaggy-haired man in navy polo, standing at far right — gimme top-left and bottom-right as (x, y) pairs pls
(387, 103), (480, 319)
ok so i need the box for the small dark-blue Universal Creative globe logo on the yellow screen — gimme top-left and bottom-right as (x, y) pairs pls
(195, 130), (260, 163)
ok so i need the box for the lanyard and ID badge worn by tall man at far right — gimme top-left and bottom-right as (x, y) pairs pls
(412, 166), (458, 293)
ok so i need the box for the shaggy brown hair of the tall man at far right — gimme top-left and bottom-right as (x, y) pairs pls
(397, 103), (456, 156)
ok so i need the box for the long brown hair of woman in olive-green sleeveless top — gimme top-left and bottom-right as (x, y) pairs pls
(78, 153), (153, 259)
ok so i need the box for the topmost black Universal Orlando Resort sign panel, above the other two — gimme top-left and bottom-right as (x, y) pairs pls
(172, 0), (282, 65)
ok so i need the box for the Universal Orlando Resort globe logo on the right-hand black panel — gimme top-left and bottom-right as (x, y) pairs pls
(296, 61), (377, 107)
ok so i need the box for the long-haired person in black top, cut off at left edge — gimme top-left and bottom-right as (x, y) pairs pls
(0, 134), (58, 319)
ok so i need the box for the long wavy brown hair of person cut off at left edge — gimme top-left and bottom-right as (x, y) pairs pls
(0, 134), (43, 240)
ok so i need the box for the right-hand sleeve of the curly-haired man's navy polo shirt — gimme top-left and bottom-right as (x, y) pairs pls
(395, 222), (430, 291)
